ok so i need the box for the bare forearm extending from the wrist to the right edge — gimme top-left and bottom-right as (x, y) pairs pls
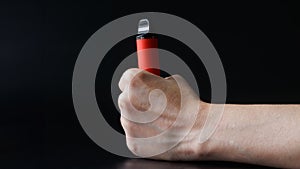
(204, 104), (300, 168)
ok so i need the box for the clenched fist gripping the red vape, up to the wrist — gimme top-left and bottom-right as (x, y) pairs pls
(118, 69), (208, 160)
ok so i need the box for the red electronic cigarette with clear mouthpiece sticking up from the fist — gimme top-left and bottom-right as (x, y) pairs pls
(136, 19), (160, 76)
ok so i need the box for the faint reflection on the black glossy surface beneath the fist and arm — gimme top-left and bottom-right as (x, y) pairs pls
(117, 159), (276, 169)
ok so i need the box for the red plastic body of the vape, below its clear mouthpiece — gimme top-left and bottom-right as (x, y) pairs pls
(136, 38), (160, 76)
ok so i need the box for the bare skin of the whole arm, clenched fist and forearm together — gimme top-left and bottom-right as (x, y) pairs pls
(118, 69), (300, 168)
